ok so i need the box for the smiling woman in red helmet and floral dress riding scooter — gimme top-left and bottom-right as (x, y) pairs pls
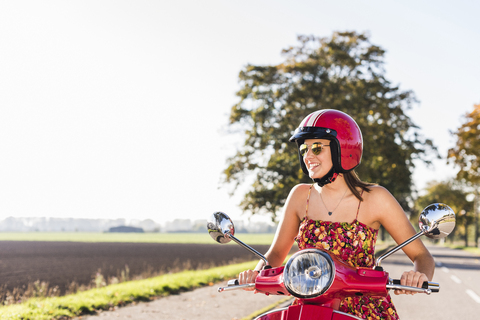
(239, 109), (435, 319)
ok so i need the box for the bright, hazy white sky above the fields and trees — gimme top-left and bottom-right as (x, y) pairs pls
(0, 0), (480, 222)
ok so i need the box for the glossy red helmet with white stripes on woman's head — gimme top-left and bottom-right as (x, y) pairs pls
(290, 109), (363, 179)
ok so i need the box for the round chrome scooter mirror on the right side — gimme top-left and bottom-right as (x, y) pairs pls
(418, 203), (455, 239)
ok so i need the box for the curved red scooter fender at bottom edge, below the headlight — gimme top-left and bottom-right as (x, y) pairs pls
(255, 304), (361, 320)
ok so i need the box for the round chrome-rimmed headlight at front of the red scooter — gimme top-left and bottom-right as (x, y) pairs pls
(283, 249), (335, 298)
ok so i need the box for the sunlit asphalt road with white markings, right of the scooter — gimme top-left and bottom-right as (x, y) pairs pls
(382, 247), (480, 320)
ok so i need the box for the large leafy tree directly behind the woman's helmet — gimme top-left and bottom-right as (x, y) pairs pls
(224, 32), (437, 220)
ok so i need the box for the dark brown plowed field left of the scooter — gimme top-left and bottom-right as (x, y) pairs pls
(0, 241), (282, 292)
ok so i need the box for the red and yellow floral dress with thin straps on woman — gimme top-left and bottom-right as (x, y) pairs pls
(295, 185), (399, 320)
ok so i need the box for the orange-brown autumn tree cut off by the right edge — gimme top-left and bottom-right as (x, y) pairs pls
(448, 104), (480, 241)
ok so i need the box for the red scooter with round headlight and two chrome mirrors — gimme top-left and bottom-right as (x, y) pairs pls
(207, 203), (455, 320)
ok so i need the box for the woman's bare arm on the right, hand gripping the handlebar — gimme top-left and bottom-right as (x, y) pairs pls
(369, 187), (435, 294)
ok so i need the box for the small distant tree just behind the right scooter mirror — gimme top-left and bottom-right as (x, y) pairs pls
(411, 181), (473, 247)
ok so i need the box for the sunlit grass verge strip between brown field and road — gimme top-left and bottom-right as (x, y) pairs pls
(0, 261), (257, 320)
